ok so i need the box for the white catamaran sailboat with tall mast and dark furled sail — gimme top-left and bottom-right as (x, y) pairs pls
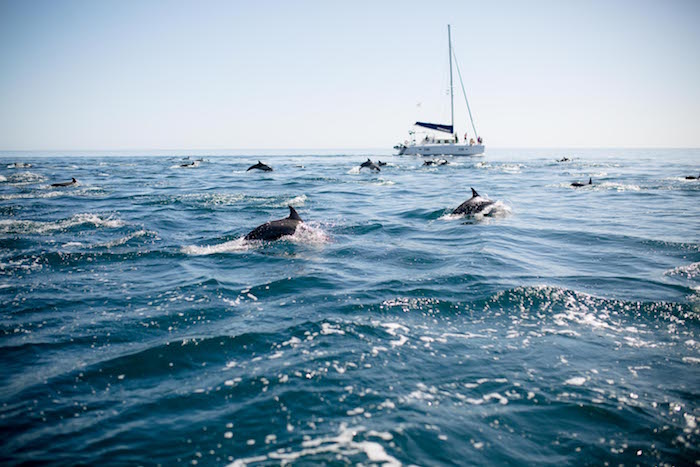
(394, 24), (485, 156)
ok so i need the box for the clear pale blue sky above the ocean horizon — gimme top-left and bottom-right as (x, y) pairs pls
(0, 0), (700, 150)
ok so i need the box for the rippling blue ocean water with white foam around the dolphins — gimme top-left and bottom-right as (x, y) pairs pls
(0, 149), (700, 466)
